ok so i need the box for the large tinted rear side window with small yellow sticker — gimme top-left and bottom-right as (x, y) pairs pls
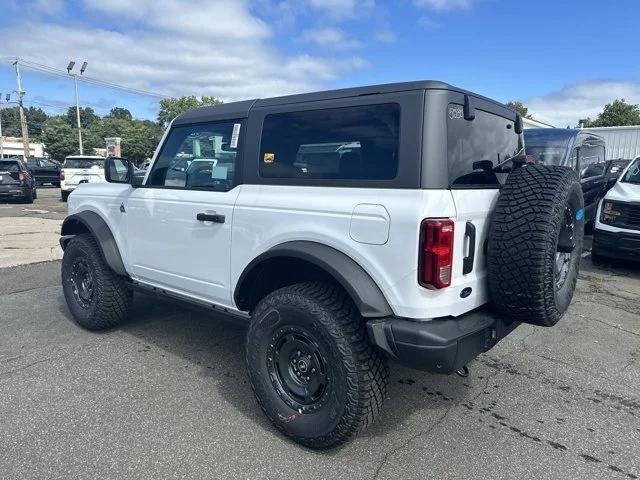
(260, 103), (400, 180)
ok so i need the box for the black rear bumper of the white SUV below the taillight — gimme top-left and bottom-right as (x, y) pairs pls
(367, 307), (520, 374)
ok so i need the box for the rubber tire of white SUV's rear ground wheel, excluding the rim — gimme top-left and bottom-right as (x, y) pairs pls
(245, 282), (388, 448)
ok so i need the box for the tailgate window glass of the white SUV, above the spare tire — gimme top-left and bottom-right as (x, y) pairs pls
(447, 104), (523, 188)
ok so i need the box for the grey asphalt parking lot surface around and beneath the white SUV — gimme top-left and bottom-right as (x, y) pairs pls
(0, 193), (640, 479)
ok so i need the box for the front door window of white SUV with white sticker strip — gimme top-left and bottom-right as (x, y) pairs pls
(147, 121), (242, 191)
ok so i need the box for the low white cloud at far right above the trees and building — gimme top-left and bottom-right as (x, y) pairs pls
(523, 80), (640, 127)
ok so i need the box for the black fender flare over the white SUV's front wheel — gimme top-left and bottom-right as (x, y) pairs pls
(60, 210), (129, 276)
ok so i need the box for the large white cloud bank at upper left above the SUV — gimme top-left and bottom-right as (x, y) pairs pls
(0, 0), (366, 101)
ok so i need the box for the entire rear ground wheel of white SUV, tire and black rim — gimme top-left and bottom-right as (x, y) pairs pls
(246, 282), (388, 448)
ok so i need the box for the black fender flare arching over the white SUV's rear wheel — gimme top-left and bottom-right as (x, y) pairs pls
(233, 240), (393, 318)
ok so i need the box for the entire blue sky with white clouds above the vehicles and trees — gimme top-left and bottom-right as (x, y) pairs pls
(0, 0), (640, 127)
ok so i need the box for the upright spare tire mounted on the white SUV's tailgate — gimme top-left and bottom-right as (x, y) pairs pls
(487, 165), (584, 327)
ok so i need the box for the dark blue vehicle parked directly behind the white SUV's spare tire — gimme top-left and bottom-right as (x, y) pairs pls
(524, 128), (617, 226)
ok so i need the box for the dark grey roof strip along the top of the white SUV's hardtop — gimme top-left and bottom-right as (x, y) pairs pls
(173, 80), (506, 125)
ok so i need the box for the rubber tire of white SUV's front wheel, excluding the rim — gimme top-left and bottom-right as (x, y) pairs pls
(62, 234), (133, 330)
